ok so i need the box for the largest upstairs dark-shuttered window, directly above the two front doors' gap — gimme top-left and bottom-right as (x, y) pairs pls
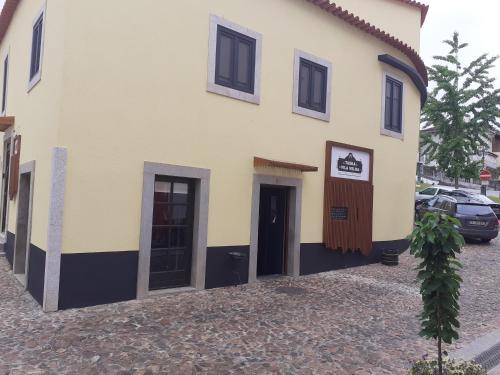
(215, 25), (257, 94)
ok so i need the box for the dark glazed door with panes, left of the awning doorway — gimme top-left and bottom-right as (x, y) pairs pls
(149, 176), (194, 290)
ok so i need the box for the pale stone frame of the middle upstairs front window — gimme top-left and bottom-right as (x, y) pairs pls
(292, 49), (333, 122)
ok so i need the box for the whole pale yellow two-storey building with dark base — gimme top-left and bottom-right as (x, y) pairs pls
(0, 0), (427, 311)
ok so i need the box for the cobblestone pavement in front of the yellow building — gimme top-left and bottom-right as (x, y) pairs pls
(0, 241), (500, 375)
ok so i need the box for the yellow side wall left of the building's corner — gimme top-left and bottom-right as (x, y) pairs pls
(0, 0), (65, 250)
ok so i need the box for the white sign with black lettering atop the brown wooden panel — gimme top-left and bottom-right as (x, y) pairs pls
(331, 146), (370, 181)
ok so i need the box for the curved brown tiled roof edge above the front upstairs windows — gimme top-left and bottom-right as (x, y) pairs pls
(306, 0), (429, 85)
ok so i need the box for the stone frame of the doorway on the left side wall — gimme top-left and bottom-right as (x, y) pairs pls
(13, 162), (34, 287)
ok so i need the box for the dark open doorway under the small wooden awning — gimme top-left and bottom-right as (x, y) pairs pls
(257, 186), (288, 276)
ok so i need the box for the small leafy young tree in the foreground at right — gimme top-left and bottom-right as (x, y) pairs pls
(410, 213), (465, 375)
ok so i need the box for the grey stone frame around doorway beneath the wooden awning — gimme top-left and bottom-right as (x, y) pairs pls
(248, 174), (302, 283)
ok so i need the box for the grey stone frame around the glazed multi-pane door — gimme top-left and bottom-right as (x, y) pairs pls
(137, 162), (210, 299)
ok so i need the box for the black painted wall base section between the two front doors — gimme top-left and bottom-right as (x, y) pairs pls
(205, 246), (250, 289)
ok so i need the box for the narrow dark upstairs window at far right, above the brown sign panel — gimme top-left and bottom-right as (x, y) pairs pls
(384, 77), (403, 133)
